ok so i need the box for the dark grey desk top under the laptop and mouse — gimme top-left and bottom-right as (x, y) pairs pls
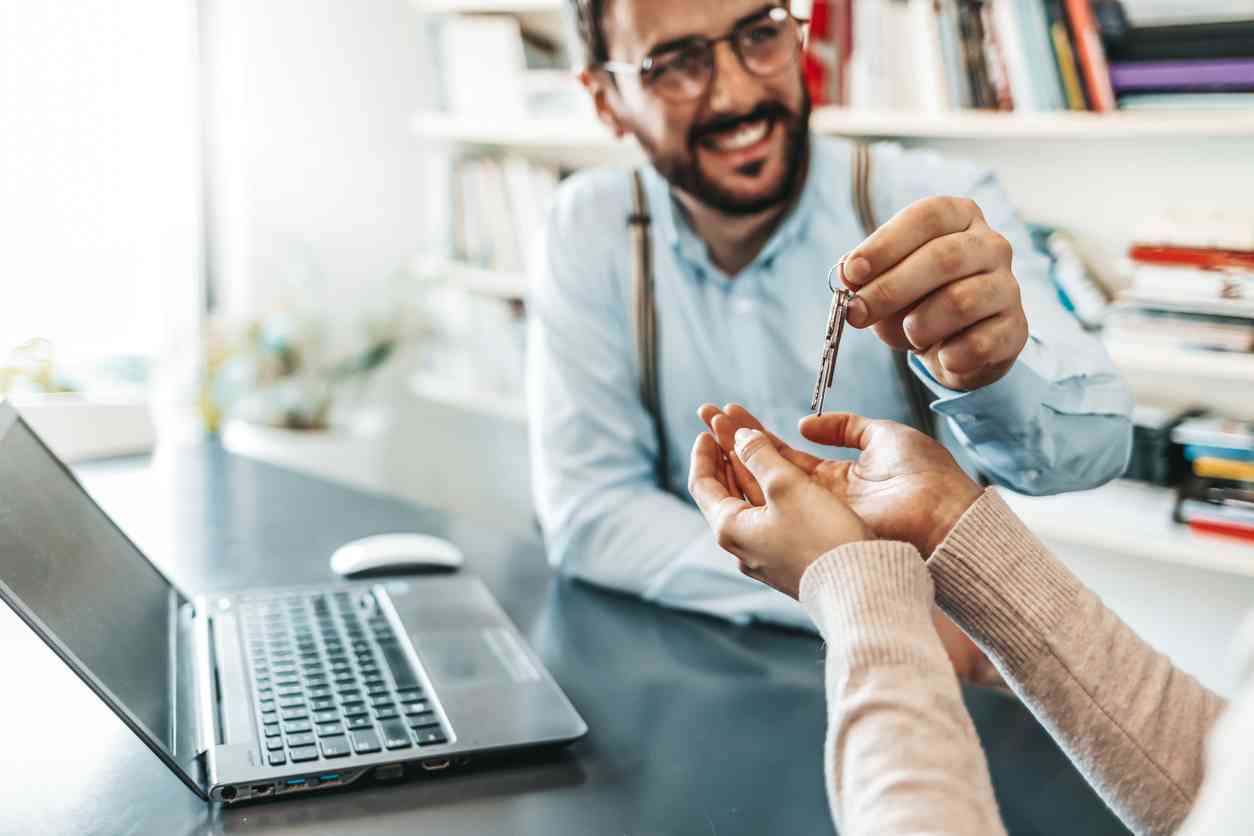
(0, 446), (1126, 836)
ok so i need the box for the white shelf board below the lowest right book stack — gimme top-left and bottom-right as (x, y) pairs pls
(1001, 480), (1254, 578)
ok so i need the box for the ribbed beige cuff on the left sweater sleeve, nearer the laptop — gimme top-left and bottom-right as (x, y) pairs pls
(799, 540), (933, 668)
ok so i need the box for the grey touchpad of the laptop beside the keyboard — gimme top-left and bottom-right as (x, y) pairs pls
(414, 628), (539, 686)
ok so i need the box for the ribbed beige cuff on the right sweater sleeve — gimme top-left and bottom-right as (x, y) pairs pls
(927, 488), (1082, 674)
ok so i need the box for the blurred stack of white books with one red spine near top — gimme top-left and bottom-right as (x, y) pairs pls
(1106, 214), (1254, 353)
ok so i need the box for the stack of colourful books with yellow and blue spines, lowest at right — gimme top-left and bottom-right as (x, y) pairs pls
(1171, 417), (1254, 540)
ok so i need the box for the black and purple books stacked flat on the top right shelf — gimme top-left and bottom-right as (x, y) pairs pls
(1105, 3), (1254, 109)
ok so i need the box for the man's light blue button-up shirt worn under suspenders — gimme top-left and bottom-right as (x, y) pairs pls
(528, 137), (1131, 624)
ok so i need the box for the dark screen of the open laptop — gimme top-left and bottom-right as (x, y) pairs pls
(0, 404), (179, 751)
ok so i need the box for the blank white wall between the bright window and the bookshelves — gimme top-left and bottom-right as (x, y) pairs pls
(204, 0), (429, 313)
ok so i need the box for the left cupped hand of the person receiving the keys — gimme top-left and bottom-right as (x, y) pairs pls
(688, 429), (870, 598)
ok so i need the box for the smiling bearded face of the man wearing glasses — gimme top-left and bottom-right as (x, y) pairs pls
(598, 0), (810, 214)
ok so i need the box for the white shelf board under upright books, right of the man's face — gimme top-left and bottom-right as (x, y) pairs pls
(810, 107), (1254, 140)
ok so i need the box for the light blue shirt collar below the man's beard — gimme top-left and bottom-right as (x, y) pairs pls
(645, 134), (830, 276)
